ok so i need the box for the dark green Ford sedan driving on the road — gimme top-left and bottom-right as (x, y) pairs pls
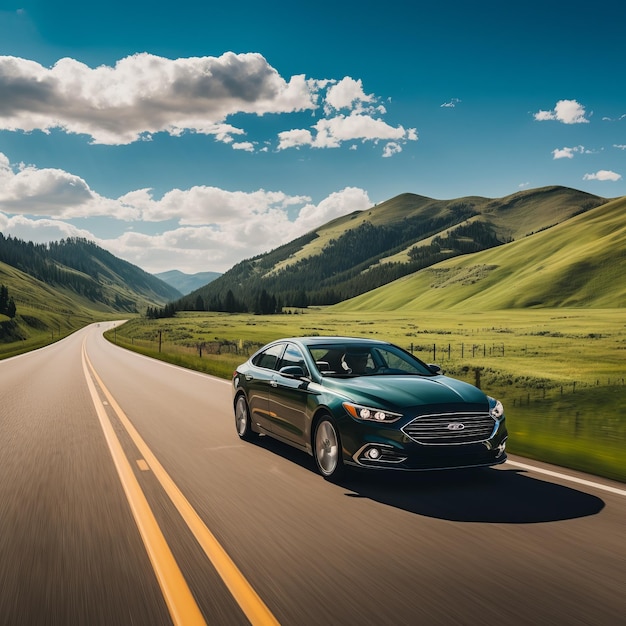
(233, 337), (507, 479)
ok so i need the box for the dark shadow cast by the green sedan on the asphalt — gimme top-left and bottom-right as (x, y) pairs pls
(250, 437), (604, 524)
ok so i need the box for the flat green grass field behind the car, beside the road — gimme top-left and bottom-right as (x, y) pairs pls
(108, 308), (626, 482)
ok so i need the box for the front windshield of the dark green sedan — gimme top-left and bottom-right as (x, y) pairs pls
(309, 343), (434, 377)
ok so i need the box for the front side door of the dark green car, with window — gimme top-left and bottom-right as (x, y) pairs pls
(269, 343), (311, 447)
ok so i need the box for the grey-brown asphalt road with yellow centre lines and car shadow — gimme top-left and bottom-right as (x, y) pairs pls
(0, 324), (626, 626)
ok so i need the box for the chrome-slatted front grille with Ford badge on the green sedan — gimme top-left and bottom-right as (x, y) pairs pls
(402, 413), (496, 445)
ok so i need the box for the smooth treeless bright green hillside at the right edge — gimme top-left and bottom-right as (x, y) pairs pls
(334, 198), (626, 312)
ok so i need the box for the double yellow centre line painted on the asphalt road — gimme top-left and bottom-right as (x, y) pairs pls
(82, 342), (278, 626)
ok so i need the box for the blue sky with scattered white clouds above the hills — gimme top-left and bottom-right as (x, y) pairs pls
(0, 0), (626, 273)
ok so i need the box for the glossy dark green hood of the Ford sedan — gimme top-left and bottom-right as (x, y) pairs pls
(324, 376), (487, 409)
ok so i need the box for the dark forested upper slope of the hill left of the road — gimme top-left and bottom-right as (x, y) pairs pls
(0, 233), (182, 313)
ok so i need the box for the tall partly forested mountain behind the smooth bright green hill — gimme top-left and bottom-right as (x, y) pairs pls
(174, 187), (607, 313)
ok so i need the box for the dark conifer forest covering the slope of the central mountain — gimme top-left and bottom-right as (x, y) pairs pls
(149, 203), (504, 317)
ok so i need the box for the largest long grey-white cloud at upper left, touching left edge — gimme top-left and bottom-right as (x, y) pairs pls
(0, 52), (317, 145)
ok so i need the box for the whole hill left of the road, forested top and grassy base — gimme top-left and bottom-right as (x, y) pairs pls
(0, 233), (181, 342)
